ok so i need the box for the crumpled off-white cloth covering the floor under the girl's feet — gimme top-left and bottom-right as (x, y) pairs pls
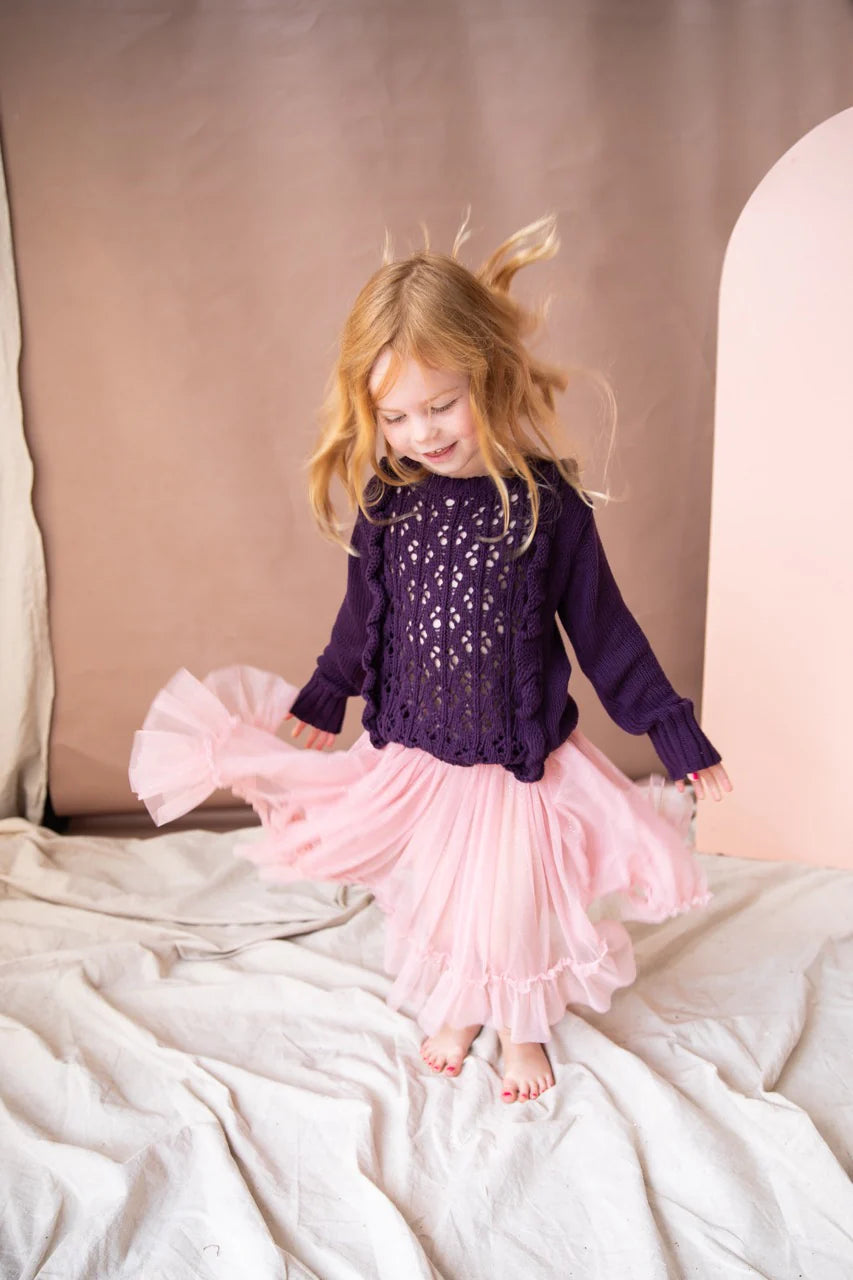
(0, 819), (853, 1280)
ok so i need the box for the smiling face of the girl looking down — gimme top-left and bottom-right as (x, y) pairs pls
(368, 348), (487, 479)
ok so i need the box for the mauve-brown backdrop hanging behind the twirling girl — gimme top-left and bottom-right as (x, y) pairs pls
(0, 0), (853, 814)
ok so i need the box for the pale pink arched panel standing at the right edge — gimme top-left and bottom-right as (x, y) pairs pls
(697, 109), (853, 867)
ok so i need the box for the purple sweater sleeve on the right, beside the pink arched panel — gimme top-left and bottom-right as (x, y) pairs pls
(557, 499), (721, 781)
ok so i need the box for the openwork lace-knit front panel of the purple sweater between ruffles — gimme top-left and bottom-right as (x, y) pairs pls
(375, 476), (529, 763)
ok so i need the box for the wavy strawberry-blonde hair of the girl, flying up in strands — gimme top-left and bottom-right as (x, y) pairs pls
(307, 211), (615, 554)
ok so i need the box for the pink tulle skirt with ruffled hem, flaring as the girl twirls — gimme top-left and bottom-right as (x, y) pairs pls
(129, 666), (710, 1043)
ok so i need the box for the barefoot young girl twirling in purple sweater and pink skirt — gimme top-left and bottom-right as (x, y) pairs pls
(131, 219), (731, 1102)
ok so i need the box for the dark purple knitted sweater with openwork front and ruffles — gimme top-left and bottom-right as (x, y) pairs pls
(292, 460), (721, 782)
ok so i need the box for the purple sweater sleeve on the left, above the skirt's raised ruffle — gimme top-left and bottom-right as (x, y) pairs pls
(291, 511), (370, 733)
